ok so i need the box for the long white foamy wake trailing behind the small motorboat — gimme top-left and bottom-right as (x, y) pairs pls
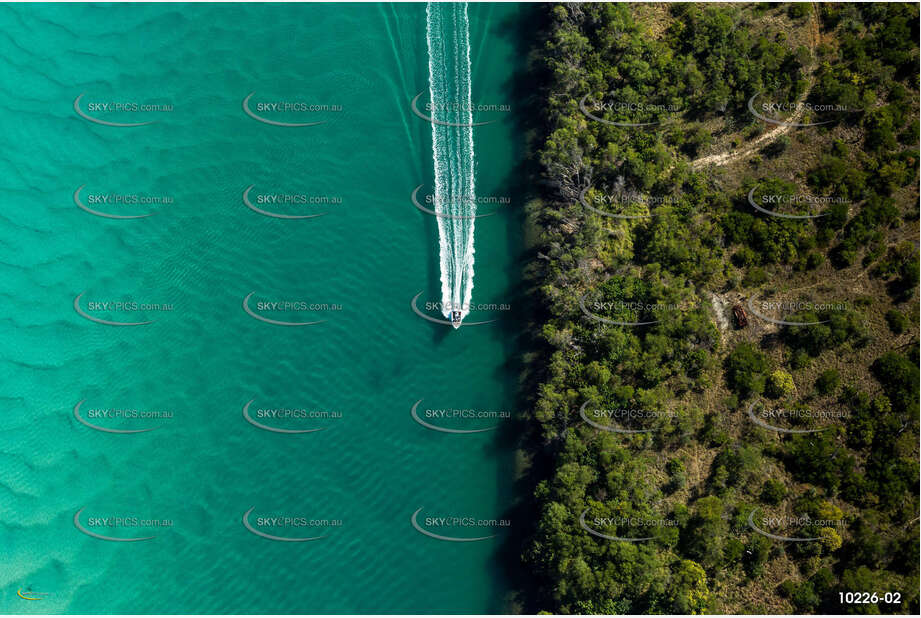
(426, 2), (476, 318)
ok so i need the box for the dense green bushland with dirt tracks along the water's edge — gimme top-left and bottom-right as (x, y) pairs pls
(522, 3), (919, 614)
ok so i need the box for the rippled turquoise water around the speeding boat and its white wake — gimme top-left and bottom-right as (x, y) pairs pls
(0, 4), (522, 613)
